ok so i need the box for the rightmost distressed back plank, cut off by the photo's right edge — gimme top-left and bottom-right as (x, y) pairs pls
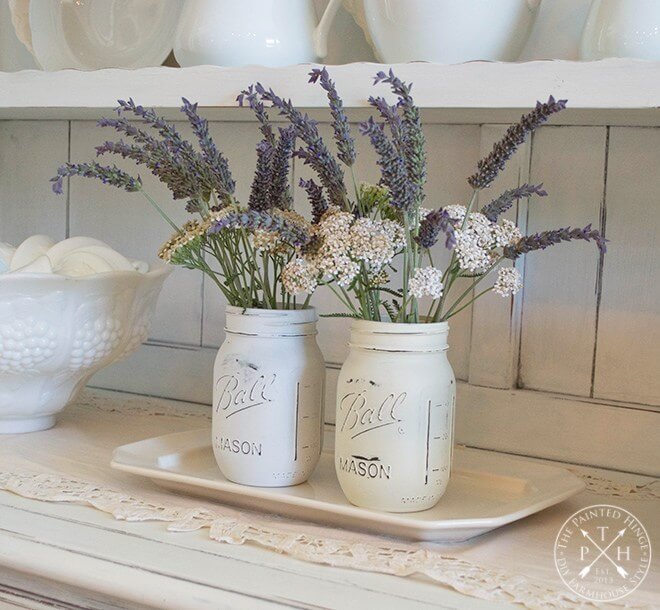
(594, 128), (660, 405)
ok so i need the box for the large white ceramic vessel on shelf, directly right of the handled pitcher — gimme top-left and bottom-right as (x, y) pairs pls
(348, 0), (541, 63)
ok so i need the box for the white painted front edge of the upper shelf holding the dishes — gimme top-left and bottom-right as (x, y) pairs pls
(0, 59), (660, 118)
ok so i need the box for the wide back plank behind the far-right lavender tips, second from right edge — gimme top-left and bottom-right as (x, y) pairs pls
(519, 127), (604, 396)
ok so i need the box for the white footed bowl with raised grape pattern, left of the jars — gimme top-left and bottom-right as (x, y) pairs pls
(0, 265), (170, 434)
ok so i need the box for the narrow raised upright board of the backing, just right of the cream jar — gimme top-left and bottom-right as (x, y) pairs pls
(469, 125), (530, 388)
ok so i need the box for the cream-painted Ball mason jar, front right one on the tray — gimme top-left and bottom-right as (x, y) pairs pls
(335, 320), (456, 513)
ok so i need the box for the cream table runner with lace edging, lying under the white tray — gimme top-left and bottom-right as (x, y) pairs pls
(0, 392), (660, 608)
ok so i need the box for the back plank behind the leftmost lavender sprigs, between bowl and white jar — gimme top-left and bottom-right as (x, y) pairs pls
(68, 121), (202, 345)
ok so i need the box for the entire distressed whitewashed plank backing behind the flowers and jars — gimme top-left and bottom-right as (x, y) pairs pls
(0, 120), (660, 473)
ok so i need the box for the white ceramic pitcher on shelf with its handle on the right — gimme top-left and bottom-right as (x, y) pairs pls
(174, 0), (341, 67)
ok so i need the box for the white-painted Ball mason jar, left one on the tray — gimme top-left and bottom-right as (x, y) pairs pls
(213, 306), (325, 487)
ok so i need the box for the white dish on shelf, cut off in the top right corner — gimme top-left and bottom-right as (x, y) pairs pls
(580, 0), (660, 61)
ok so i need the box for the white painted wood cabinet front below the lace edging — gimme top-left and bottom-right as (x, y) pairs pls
(0, 478), (506, 610)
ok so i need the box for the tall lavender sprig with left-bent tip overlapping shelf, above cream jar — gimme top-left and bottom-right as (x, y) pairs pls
(374, 69), (426, 195)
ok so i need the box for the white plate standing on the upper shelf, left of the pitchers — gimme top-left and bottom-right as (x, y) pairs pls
(29, 0), (181, 70)
